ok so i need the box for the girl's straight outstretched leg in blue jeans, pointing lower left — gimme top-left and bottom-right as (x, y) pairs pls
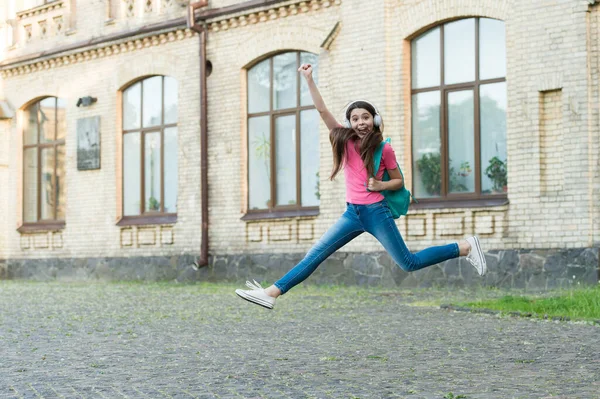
(275, 211), (364, 294)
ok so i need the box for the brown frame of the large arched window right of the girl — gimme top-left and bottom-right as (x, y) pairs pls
(409, 17), (508, 209)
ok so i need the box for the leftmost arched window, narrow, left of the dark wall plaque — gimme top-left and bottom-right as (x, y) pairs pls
(23, 97), (67, 223)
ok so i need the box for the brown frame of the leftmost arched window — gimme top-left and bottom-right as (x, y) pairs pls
(17, 96), (67, 233)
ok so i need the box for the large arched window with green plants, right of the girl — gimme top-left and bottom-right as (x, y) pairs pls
(411, 18), (507, 202)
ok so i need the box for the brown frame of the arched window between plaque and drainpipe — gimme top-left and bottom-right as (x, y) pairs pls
(117, 75), (179, 226)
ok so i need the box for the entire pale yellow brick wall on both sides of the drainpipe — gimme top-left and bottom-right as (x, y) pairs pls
(0, 0), (600, 258)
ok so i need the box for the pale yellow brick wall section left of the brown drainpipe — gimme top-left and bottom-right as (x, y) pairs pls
(3, 32), (200, 258)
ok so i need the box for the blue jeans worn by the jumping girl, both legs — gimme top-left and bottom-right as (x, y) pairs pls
(275, 200), (459, 293)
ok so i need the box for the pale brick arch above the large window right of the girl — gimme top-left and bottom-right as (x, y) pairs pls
(396, 0), (510, 39)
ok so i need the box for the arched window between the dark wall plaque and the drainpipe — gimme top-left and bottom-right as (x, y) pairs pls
(122, 76), (178, 217)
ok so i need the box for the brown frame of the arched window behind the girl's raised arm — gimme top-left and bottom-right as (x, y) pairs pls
(242, 50), (319, 220)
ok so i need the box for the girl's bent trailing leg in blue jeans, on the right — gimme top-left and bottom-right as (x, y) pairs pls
(367, 205), (459, 272)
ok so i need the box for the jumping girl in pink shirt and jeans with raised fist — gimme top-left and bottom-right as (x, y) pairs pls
(235, 64), (487, 309)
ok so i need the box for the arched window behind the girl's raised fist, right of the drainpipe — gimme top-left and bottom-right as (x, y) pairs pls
(248, 51), (320, 213)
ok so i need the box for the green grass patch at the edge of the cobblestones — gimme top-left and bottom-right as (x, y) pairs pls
(456, 286), (600, 321)
